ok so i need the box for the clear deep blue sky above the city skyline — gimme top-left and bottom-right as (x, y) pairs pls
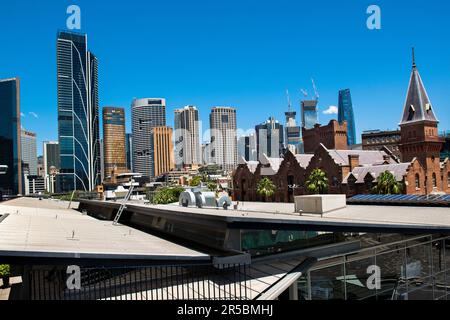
(0, 0), (450, 155)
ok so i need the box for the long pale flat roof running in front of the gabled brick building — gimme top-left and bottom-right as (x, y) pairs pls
(152, 202), (450, 229)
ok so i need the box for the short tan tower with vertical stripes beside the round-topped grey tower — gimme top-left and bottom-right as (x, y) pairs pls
(151, 127), (175, 177)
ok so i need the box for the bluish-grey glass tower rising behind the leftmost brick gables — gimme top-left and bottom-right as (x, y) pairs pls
(255, 117), (284, 159)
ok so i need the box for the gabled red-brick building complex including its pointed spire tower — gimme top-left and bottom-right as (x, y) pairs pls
(233, 53), (450, 202)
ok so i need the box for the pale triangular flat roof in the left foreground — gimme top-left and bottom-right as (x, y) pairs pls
(0, 198), (208, 260)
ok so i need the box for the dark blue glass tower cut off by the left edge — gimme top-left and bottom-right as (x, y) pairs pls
(0, 78), (23, 198)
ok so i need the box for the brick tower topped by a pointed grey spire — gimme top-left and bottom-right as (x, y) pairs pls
(400, 48), (444, 194)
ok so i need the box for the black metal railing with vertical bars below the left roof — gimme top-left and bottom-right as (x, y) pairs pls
(27, 265), (251, 300)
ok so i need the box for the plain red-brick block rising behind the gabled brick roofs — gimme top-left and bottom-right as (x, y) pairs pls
(302, 120), (348, 154)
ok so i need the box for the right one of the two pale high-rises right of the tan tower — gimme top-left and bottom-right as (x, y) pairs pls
(209, 107), (237, 171)
